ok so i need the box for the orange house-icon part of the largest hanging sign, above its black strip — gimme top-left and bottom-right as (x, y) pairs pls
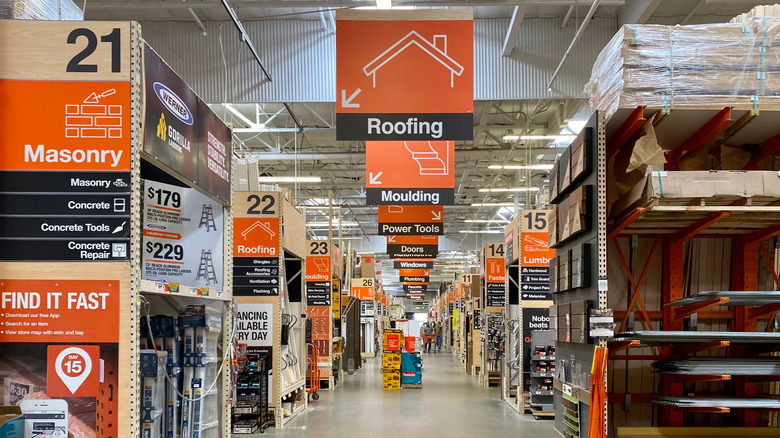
(336, 16), (474, 113)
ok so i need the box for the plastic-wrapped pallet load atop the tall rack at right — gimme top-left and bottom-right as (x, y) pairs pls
(585, 17), (780, 116)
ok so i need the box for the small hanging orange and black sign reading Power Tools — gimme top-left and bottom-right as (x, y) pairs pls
(378, 205), (444, 236)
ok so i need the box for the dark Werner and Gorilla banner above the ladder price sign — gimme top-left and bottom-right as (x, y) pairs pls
(144, 45), (231, 202)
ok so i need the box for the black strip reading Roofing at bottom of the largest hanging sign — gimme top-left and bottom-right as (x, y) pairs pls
(336, 113), (474, 141)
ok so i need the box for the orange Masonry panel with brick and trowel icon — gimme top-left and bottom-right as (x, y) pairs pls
(0, 80), (130, 171)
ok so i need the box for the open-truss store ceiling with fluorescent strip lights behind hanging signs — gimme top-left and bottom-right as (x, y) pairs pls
(85, 0), (762, 299)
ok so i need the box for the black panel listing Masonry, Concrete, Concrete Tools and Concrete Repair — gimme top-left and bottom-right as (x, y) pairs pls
(0, 171), (130, 261)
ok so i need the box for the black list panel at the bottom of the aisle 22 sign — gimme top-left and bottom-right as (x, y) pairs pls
(233, 257), (279, 296)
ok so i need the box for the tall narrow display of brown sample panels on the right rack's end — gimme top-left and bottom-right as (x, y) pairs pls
(548, 111), (611, 436)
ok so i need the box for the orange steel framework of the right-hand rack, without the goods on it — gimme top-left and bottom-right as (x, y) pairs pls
(600, 106), (780, 427)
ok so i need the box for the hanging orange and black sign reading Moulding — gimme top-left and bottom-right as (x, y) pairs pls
(366, 141), (455, 206)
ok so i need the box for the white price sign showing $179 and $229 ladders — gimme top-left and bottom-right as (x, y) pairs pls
(141, 180), (224, 291)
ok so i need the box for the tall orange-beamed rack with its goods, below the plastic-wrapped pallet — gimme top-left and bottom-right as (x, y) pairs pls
(606, 107), (780, 433)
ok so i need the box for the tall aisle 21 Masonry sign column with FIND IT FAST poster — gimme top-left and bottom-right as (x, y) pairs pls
(0, 20), (134, 438)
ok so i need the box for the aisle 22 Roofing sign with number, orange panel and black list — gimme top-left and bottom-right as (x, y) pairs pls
(233, 192), (281, 296)
